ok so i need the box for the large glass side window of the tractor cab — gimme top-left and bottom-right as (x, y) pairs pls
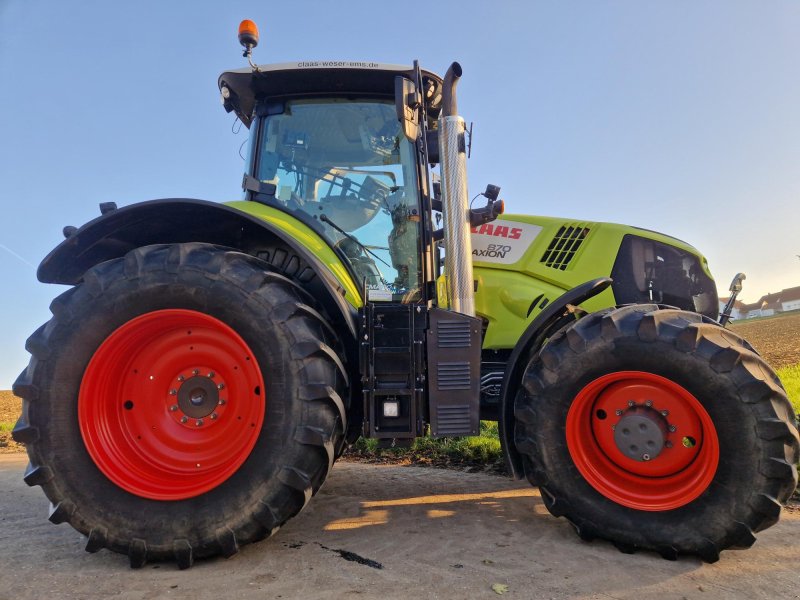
(256, 98), (421, 302)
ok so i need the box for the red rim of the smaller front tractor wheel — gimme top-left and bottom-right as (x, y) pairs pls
(566, 371), (719, 511)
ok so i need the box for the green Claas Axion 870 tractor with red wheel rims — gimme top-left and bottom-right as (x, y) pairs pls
(13, 21), (798, 568)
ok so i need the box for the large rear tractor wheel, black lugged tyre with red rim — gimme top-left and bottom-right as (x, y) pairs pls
(14, 244), (348, 568)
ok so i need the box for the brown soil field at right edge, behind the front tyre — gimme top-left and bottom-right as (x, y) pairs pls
(730, 310), (800, 369)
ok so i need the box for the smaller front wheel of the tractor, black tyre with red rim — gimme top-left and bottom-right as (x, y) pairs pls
(515, 305), (799, 562)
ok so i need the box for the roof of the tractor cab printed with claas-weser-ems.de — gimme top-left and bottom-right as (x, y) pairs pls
(217, 60), (442, 127)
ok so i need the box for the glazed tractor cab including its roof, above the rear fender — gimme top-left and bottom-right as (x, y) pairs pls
(219, 62), (442, 303)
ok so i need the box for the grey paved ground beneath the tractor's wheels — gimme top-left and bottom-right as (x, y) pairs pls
(0, 455), (800, 600)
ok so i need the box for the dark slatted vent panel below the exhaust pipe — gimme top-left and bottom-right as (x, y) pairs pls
(428, 308), (482, 437)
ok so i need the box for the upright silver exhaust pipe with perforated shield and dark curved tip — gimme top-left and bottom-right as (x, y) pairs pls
(439, 62), (475, 317)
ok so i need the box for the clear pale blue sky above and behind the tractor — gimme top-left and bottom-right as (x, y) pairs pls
(0, 0), (800, 389)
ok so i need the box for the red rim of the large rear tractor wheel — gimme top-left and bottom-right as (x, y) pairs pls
(78, 309), (265, 500)
